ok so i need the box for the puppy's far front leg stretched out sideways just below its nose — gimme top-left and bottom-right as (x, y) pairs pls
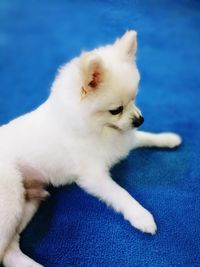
(132, 131), (181, 149)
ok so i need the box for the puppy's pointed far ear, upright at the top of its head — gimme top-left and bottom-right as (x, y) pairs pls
(114, 31), (137, 61)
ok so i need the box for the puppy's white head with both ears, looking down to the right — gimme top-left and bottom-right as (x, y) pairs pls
(80, 31), (144, 131)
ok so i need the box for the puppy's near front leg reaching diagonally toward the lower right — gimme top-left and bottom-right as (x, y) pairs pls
(77, 173), (157, 234)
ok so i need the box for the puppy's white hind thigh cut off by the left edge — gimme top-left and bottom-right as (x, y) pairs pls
(0, 165), (24, 262)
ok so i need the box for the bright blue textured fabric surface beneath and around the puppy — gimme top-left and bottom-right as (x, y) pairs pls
(0, 0), (200, 267)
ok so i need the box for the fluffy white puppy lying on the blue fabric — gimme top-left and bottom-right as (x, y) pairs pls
(0, 31), (181, 267)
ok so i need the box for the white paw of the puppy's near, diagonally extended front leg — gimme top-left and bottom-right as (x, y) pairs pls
(129, 209), (157, 235)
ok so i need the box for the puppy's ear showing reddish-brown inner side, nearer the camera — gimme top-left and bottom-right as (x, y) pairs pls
(81, 53), (104, 94)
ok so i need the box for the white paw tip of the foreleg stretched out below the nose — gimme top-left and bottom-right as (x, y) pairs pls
(159, 133), (182, 148)
